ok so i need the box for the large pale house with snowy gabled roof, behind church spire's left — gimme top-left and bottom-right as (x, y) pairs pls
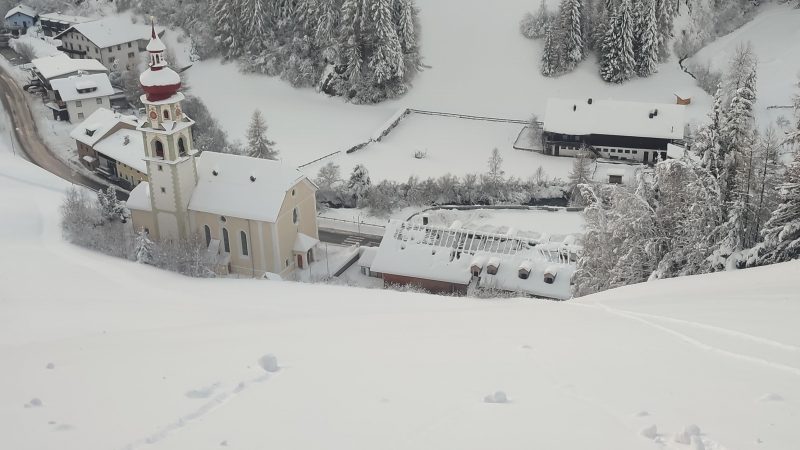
(56, 17), (164, 70)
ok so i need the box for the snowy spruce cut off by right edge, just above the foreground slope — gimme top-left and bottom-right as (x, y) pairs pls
(758, 151), (800, 264)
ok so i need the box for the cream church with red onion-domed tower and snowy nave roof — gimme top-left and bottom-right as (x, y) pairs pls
(127, 27), (319, 277)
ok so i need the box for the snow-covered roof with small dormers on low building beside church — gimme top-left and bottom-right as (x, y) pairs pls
(370, 221), (574, 299)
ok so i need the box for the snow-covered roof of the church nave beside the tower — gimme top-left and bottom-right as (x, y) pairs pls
(189, 152), (305, 222)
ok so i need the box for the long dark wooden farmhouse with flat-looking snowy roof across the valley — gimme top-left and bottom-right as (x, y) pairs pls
(542, 98), (685, 164)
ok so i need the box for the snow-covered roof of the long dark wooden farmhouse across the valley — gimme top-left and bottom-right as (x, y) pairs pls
(544, 98), (685, 139)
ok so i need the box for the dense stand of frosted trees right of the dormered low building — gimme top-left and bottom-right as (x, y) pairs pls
(573, 46), (800, 295)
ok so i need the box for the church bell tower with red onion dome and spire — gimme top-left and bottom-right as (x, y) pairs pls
(137, 18), (197, 239)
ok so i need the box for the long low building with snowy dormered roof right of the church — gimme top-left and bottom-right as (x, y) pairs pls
(368, 221), (575, 300)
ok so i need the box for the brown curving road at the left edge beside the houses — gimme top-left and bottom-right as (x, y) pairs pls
(0, 61), (114, 195)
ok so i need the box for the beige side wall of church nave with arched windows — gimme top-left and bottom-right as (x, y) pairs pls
(189, 211), (272, 277)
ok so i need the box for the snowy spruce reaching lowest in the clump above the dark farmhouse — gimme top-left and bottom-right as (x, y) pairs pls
(600, 0), (636, 83)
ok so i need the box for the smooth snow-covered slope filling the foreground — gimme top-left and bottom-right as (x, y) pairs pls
(0, 139), (800, 450)
